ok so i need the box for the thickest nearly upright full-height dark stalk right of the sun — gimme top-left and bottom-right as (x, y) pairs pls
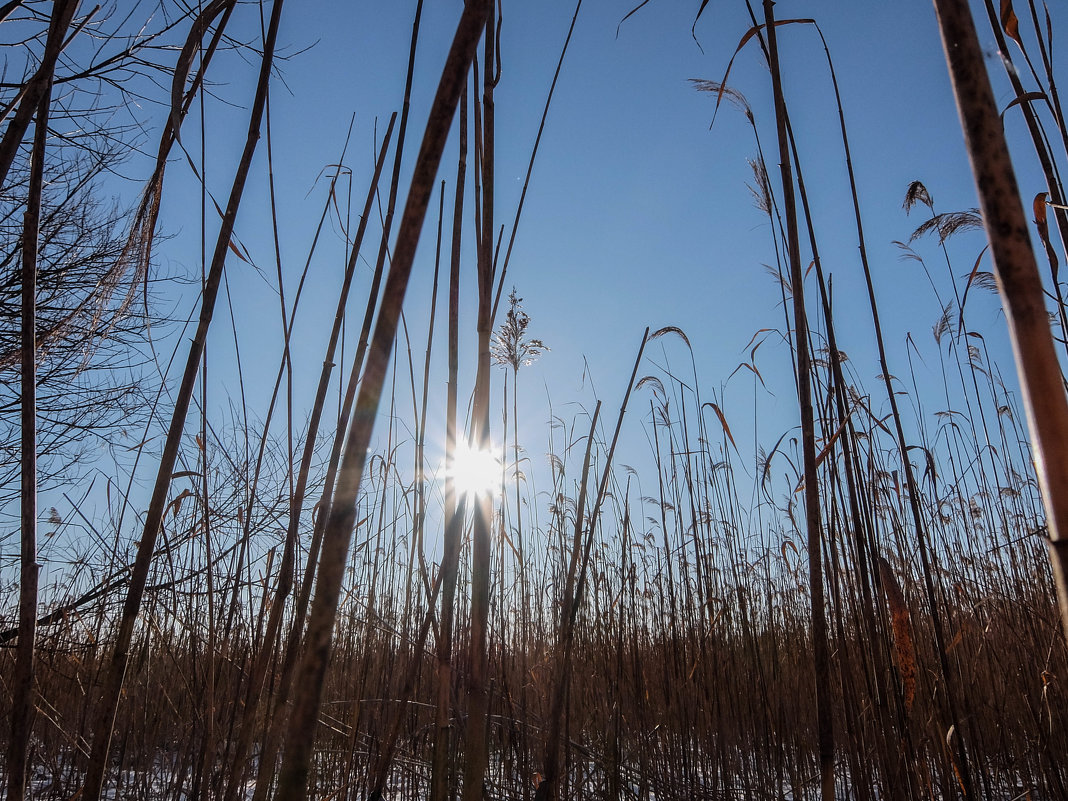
(764, 0), (834, 801)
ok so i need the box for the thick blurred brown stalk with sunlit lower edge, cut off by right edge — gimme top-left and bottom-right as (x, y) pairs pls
(935, 0), (1068, 634)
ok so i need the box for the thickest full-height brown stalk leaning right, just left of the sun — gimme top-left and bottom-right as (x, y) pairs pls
(278, 2), (488, 801)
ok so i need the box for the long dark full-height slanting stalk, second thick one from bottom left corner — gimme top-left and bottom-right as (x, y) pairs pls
(83, 0), (283, 801)
